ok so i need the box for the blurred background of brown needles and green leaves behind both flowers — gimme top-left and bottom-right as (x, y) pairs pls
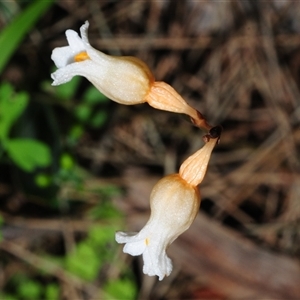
(0, 0), (300, 300)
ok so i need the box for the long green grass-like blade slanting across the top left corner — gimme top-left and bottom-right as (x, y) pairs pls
(0, 0), (53, 73)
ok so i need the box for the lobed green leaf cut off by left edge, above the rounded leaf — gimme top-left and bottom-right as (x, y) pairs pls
(0, 83), (28, 139)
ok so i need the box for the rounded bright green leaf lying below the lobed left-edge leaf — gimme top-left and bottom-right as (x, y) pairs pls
(6, 139), (51, 172)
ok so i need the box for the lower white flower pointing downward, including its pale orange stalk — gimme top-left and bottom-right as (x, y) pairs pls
(116, 139), (217, 280)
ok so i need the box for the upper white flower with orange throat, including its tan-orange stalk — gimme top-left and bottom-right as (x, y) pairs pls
(51, 21), (211, 130)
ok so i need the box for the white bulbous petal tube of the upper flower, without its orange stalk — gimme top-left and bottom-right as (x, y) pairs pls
(51, 21), (154, 105)
